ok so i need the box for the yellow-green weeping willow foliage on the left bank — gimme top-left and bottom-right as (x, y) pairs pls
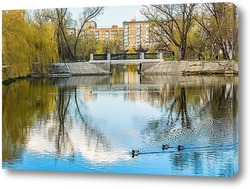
(2, 10), (57, 80)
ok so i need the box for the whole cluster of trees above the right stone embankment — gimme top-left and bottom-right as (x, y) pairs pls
(141, 3), (238, 60)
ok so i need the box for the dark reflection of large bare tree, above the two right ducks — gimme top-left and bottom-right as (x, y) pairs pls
(145, 84), (193, 145)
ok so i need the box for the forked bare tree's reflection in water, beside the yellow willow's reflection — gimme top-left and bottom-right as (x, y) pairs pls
(49, 83), (110, 161)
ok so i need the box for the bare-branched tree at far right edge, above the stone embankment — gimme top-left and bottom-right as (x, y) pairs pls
(194, 3), (238, 59)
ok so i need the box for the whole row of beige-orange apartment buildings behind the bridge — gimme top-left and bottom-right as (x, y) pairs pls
(68, 20), (158, 51)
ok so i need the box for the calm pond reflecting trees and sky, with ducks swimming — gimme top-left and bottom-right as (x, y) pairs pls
(2, 65), (238, 177)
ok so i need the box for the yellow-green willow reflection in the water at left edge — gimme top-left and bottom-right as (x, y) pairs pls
(2, 79), (57, 166)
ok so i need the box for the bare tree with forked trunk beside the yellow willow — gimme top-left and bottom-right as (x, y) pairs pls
(36, 7), (103, 61)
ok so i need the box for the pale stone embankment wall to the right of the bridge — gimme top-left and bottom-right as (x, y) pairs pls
(142, 61), (238, 75)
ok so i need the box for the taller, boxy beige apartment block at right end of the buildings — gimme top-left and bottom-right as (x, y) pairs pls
(123, 20), (155, 50)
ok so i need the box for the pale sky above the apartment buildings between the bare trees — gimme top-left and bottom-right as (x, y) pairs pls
(69, 5), (145, 28)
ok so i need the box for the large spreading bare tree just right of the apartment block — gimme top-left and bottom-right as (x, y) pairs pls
(141, 4), (196, 60)
